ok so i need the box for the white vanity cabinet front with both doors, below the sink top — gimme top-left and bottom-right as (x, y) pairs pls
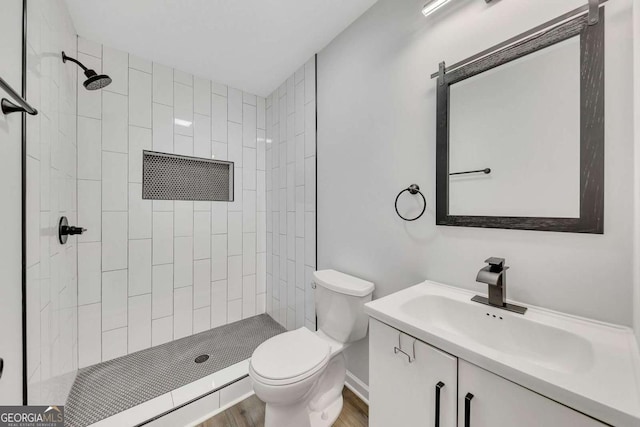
(369, 318), (606, 427)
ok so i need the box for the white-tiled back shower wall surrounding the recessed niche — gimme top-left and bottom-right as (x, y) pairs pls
(78, 38), (266, 367)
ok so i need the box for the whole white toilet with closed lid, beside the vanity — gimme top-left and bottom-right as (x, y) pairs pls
(249, 270), (374, 427)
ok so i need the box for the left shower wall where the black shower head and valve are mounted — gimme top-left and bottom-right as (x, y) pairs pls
(25, 0), (78, 404)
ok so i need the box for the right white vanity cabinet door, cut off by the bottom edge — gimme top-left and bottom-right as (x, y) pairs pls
(458, 359), (605, 427)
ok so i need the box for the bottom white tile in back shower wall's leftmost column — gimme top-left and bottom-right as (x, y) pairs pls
(79, 303), (102, 368)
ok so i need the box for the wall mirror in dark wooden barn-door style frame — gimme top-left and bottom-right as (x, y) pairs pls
(436, 11), (604, 233)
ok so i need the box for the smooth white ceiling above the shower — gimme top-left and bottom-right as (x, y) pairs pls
(66, 0), (377, 96)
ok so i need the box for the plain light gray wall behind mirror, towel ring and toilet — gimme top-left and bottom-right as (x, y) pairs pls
(318, 0), (634, 382)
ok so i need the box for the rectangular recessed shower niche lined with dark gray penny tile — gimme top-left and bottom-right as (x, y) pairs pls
(142, 150), (234, 202)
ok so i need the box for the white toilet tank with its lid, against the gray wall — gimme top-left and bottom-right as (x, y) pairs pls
(313, 270), (374, 343)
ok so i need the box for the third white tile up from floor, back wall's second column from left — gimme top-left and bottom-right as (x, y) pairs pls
(102, 212), (127, 271)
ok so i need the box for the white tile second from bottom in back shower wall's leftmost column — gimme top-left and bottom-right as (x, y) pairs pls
(78, 242), (102, 305)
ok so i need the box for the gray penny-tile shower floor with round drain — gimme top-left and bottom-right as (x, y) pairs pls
(65, 314), (285, 427)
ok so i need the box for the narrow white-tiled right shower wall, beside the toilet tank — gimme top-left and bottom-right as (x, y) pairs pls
(266, 58), (316, 330)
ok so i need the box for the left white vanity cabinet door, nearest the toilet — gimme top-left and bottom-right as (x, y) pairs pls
(369, 319), (457, 427)
